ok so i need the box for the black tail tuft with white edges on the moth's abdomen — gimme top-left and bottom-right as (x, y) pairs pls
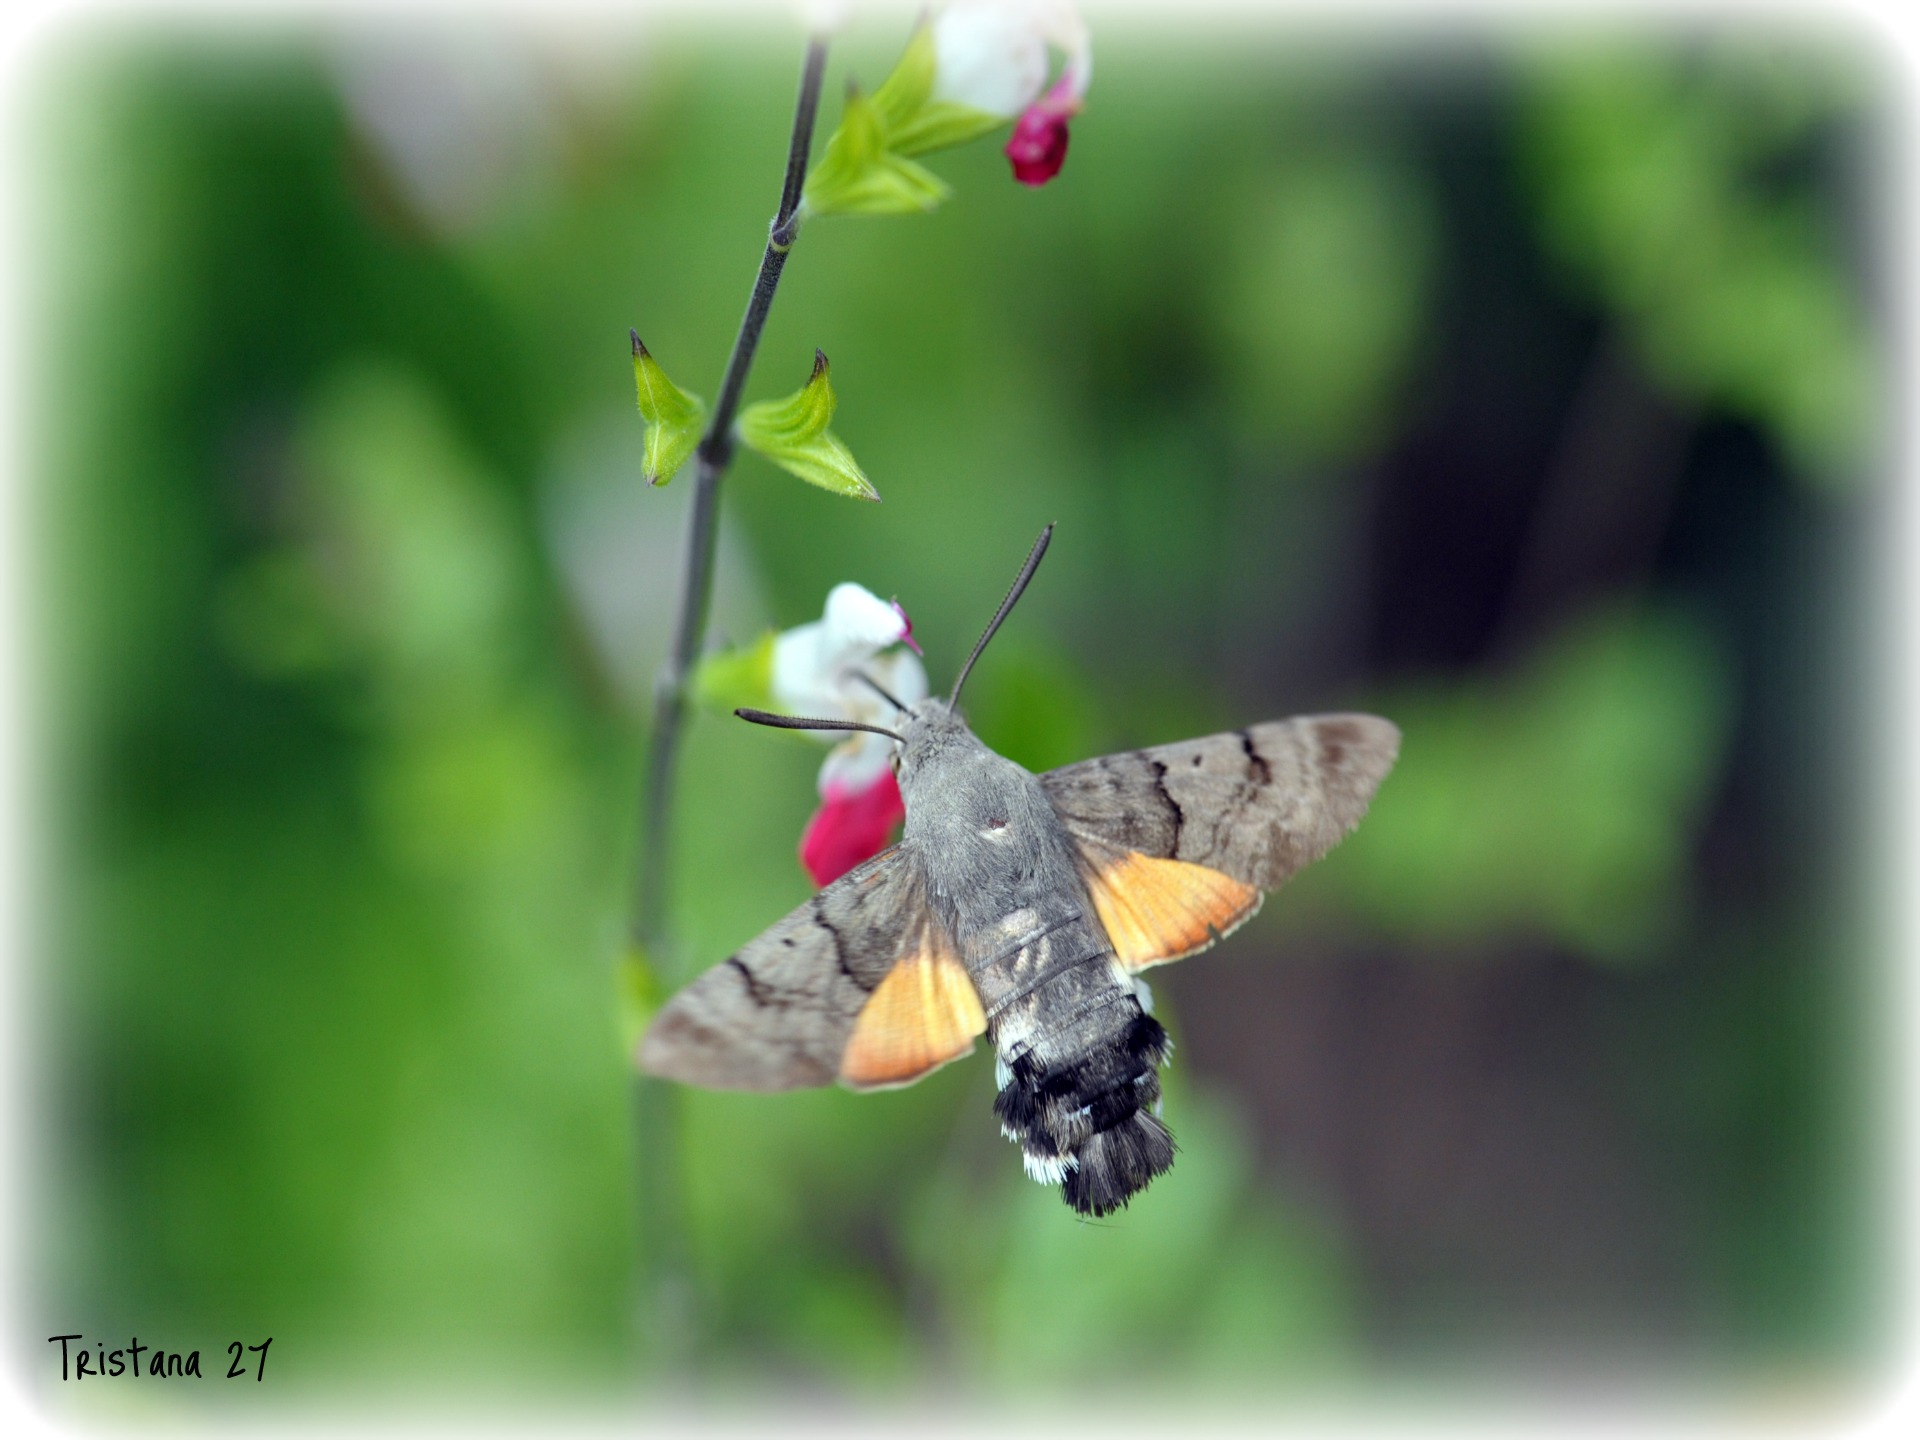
(993, 1010), (1173, 1215)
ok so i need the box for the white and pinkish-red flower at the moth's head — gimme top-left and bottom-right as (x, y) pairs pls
(772, 584), (927, 885)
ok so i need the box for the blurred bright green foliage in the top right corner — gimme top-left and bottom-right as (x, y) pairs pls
(1523, 38), (1876, 484)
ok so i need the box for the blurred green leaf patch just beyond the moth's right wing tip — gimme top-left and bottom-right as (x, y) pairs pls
(1329, 612), (1732, 962)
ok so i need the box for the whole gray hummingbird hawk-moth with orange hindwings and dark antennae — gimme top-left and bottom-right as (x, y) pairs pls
(639, 526), (1400, 1215)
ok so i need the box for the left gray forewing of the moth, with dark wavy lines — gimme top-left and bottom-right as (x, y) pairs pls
(639, 843), (933, 1091)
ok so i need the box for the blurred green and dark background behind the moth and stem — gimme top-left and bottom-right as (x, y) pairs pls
(23, 2), (1889, 1404)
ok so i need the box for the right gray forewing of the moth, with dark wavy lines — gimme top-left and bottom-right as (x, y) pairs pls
(1041, 714), (1400, 889)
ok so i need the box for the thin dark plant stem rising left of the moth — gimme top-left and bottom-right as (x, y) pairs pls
(632, 38), (828, 952)
